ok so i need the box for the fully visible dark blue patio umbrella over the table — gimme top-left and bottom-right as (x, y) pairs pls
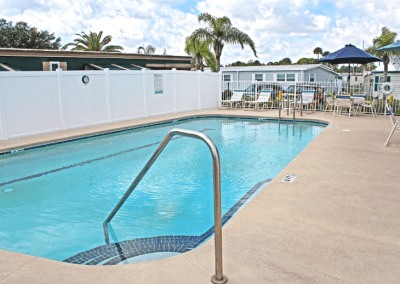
(318, 44), (383, 93)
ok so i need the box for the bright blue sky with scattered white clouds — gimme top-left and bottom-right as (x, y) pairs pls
(0, 0), (400, 65)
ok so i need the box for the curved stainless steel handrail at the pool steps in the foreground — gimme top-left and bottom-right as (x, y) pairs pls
(103, 128), (228, 283)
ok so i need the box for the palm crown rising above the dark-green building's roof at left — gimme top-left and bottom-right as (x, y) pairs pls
(61, 31), (124, 52)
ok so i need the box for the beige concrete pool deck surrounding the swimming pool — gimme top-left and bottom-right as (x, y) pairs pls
(0, 109), (400, 284)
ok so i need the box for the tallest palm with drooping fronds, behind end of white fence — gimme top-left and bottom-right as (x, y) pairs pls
(191, 13), (257, 72)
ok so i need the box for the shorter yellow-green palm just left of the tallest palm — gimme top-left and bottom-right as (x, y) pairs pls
(185, 36), (217, 72)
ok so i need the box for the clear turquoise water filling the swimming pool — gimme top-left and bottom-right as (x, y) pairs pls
(0, 118), (325, 261)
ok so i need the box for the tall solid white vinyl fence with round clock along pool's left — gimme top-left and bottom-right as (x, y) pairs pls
(0, 69), (221, 140)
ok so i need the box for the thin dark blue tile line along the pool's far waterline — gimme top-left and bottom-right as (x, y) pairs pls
(0, 115), (329, 155)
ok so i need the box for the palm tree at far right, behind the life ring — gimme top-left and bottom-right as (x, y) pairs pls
(366, 27), (398, 82)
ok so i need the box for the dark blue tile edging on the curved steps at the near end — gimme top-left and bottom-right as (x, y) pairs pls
(63, 179), (271, 265)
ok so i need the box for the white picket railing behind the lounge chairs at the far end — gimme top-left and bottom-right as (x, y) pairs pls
(222, 81), (400, 114)
